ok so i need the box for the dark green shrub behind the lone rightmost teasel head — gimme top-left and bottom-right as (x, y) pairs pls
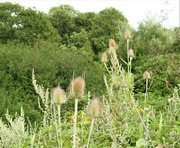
(134, 53), (180, 96)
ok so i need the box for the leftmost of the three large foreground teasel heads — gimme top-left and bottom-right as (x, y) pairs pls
(51, 86), (67, 104)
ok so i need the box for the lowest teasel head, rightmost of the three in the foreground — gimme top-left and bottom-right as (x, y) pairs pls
(87, 98), (103, 118)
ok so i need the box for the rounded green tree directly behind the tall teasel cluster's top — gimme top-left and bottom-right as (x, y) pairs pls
(89, 8), (128, 54)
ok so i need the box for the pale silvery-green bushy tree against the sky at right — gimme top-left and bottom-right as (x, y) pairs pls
(133, 18), (174, 56)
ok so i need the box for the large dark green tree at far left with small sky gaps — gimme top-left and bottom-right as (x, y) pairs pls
(0, 2), (61, 45)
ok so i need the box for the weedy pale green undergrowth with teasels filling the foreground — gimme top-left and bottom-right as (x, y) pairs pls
(0, 30), (180, 148)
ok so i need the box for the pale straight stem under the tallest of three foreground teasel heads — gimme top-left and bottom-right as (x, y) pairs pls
(73, 98), (78, 148)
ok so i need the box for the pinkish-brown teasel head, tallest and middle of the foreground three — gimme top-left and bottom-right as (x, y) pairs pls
(70, 77), (85, 99)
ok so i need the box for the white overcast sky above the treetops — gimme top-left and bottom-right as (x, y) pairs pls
(0, 0), (180, 28)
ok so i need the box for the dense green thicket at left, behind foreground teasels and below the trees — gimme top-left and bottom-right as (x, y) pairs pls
(0, 41), (104, 122)
